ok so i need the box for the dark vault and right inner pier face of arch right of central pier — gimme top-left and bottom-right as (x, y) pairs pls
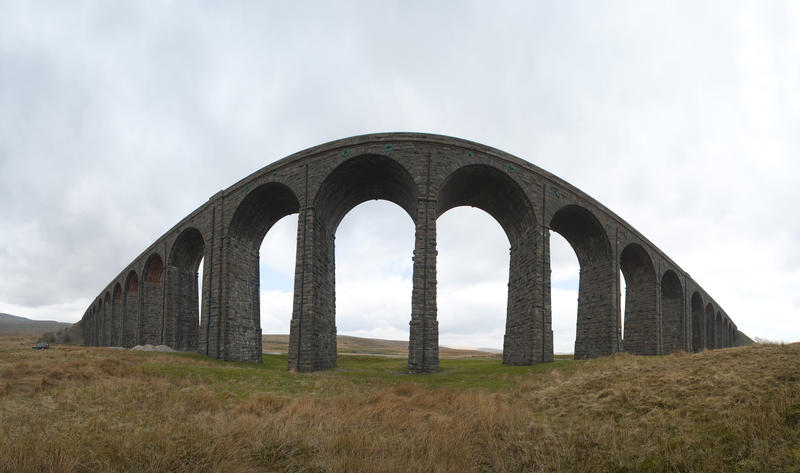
(436, 164), (540, 365)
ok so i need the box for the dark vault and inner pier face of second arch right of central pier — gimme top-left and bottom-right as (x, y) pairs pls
(550, 204), (620, 359)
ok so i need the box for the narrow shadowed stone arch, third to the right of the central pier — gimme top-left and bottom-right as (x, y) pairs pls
(619, 243), (661, 355)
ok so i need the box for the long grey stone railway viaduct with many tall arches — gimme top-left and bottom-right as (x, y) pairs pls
(82, 133), (737, 373)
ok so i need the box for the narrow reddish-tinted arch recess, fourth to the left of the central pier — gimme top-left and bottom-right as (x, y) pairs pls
(139, 253), (164, 345)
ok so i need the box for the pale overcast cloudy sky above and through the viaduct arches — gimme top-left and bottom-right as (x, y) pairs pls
(0, 0), (800, 352)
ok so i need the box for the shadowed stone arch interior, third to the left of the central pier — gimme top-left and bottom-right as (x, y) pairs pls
(163, 227), (205, 351)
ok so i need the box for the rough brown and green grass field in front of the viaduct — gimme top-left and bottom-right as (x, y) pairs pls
(0, 339), (800, 472)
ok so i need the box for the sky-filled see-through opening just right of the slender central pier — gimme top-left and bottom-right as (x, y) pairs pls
(436, 207), (506, 353)
